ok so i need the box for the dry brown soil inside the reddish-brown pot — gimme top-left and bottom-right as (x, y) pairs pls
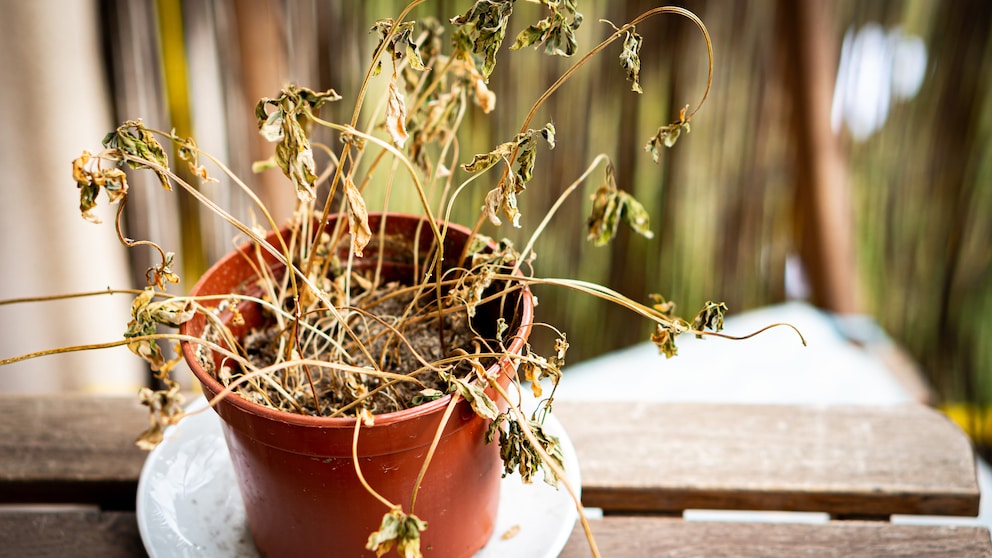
(201, 283), (504, 416)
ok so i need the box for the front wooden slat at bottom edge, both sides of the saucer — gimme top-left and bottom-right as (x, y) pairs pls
(0, 511), (992, 558)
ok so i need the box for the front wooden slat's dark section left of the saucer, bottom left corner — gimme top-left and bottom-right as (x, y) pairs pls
(0, 510), (147, 558)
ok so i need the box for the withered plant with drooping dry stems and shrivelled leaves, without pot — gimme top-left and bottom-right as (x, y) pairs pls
(3, 0), (808, 557)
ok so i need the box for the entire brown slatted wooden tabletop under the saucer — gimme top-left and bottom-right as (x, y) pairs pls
(0, 395), (992, 558)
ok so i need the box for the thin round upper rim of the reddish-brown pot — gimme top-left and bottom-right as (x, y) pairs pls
(180, 212), (534, 429)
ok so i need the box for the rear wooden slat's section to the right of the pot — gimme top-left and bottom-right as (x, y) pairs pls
(554, 401), (979, 516)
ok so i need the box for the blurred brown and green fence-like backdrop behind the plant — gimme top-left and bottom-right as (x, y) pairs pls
(0, 0), (992, 444)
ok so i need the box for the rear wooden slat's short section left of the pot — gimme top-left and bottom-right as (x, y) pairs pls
(0, 395), (148, 510)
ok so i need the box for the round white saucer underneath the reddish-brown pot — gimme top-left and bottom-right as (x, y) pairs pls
(136, 397), (581, 558)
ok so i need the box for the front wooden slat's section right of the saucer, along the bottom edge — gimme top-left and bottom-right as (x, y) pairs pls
(560, 517), (992, 558)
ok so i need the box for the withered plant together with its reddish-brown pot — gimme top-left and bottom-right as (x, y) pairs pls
(3, 0), (800, 557)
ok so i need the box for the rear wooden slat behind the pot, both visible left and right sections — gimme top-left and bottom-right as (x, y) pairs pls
(0, 395), (979, 516)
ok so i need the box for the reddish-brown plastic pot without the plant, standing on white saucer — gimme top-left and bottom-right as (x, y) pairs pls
(181, 214), (533, 558)
